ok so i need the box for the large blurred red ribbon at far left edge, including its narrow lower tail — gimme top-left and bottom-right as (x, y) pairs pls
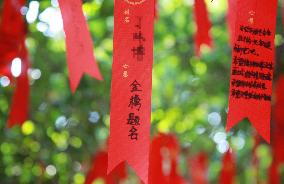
(0, 0), (29, 127)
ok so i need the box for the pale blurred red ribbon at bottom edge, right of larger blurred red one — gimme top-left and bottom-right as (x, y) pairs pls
(188, 153), (208, 184)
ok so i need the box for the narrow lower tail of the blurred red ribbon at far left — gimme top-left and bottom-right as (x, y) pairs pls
(8, 68), (30, 128)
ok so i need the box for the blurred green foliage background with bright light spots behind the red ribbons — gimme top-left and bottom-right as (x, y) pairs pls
(0, 0), (284, 184)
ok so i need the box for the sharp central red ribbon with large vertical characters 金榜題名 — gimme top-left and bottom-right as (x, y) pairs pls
(108, 0), (154, 183)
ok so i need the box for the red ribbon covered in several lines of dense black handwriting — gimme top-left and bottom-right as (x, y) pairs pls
(227, 0), (277, 142)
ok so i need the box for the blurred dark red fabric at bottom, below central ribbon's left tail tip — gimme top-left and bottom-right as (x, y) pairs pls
(85, 151), (127, 184)
